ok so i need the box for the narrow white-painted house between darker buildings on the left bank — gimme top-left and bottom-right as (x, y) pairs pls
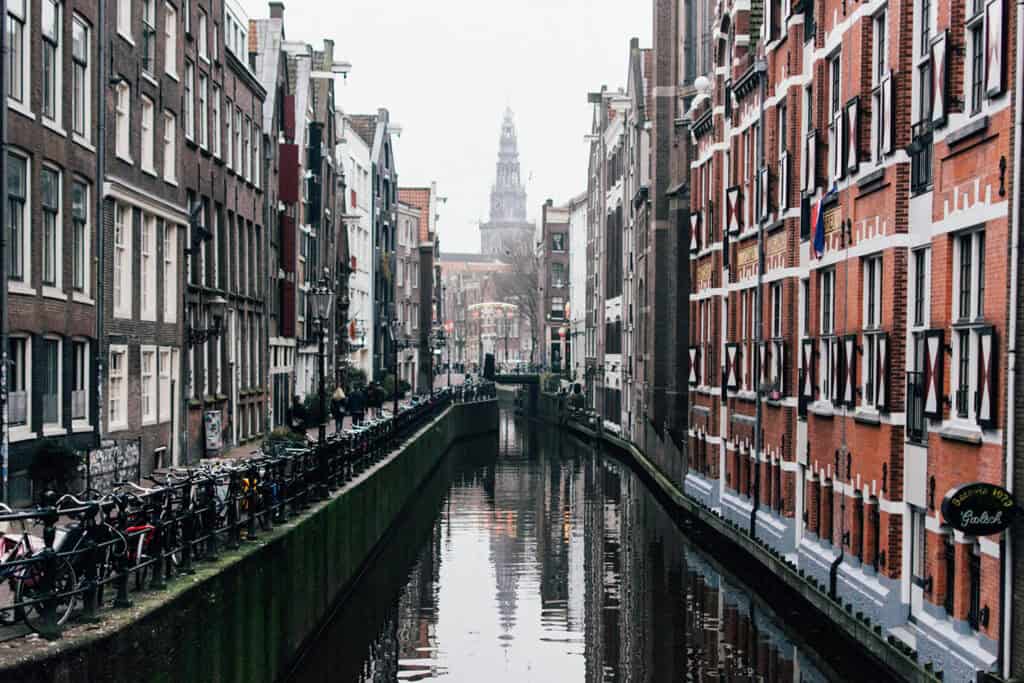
(337, 115), (374, 377)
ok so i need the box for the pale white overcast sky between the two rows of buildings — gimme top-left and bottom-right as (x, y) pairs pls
(243, 0), (652, 252)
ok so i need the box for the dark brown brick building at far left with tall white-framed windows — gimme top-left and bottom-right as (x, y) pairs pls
(4, 1), (104, 504)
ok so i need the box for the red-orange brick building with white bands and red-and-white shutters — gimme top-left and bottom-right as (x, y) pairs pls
(684, 0), (1012, 680)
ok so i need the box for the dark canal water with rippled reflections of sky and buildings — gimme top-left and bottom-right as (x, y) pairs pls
(291, 412), (884, 683)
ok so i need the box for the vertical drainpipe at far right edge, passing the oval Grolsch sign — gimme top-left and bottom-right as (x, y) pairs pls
(999, 0), (1024, 678)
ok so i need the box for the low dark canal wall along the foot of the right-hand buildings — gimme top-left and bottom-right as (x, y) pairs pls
(540, 396), (938, 683)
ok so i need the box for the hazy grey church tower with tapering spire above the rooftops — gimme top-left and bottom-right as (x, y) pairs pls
(480, 109), (534, 256)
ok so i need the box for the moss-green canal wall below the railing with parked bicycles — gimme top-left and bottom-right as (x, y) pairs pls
(0, 400), (499, 683)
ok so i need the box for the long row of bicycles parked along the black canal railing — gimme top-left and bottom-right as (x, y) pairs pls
(0, 384), (494, 638)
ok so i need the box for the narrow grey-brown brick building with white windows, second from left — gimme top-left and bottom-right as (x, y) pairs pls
(98, 2), (188, 473)
